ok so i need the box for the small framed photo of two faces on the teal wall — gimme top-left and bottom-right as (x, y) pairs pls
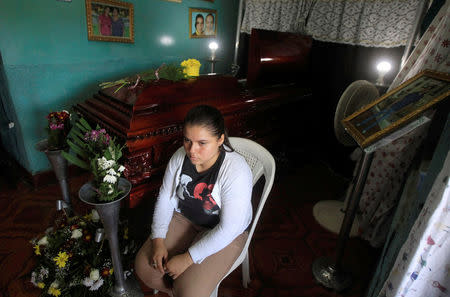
(189, 8), (217, 38)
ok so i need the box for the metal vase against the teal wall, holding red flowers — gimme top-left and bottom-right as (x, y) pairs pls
(36, 139), (72, 208)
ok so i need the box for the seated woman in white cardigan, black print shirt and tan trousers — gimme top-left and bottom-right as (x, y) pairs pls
(135, 105), (252, 297)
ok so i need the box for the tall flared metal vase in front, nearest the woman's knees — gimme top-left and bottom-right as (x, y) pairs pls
(78, 178), (144, 297)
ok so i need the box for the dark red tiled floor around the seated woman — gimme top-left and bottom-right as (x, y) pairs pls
(0, 154), (378, 297)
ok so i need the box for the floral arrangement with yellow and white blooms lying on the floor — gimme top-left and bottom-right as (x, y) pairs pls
(31, 210), (136, 297)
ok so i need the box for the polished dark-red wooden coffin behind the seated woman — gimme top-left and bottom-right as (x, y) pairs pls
(75, 31), (311, 207)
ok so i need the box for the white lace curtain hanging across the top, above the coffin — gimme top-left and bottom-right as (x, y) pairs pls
(241, 0), (425, 47)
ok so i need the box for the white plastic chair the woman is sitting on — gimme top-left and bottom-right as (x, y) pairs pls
(210, 137), (275, 297)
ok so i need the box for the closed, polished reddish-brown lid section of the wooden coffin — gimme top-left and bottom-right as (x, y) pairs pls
(76, 76), (246, 152)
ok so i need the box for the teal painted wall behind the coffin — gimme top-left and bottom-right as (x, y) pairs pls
(0, 0), (239, 174)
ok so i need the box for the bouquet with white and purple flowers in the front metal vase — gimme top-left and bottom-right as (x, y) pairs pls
(62, 118), (125, 202)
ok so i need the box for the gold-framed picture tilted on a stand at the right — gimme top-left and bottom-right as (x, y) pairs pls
(342, 70), (450, 148)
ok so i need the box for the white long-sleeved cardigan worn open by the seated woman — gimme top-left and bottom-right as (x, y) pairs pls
(151, 147), (253, 264)
